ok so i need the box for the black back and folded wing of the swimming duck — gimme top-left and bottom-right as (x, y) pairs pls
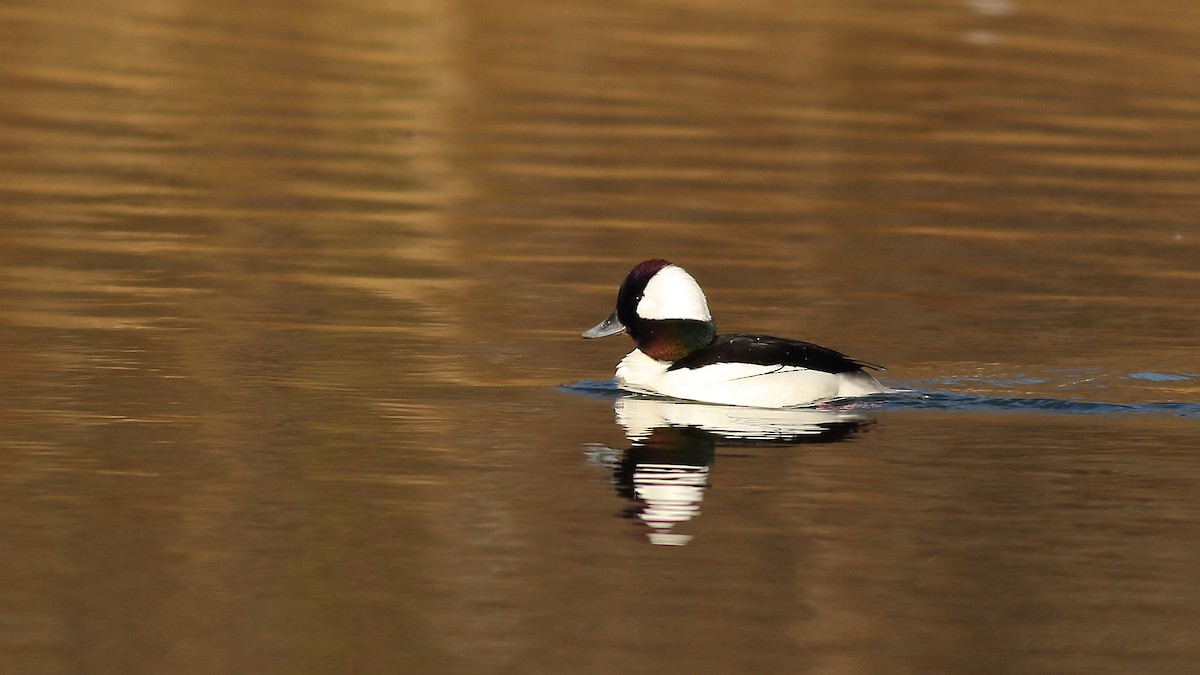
(667, 335), (883, 372)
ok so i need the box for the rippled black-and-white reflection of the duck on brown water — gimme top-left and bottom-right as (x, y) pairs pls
(588, 395), (870, 546)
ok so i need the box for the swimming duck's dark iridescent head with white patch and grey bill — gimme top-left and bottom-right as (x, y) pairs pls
(583, 258), (716, 362)
